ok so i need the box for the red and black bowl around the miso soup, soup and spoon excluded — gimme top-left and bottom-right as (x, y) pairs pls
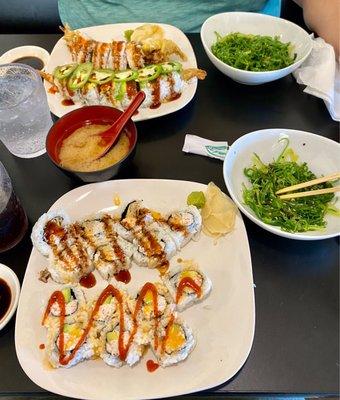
(46, 106), (137, 182)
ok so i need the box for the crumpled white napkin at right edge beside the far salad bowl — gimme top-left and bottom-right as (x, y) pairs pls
(293, 38), (340, 121)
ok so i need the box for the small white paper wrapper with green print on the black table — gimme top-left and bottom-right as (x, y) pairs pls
(182, 135), (228, 160)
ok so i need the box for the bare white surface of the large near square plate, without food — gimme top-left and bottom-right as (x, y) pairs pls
(15, 179), (255, 400)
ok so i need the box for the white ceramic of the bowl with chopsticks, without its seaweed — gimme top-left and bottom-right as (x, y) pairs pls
(223, 129), (340, 240)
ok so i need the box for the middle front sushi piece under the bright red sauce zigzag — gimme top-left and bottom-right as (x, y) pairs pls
(100, 313), (144, 368)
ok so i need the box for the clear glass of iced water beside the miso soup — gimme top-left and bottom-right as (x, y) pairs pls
(0, 64), (53, 158)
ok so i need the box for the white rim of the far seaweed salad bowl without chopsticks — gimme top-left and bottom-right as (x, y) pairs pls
(200, 11), (313, 76)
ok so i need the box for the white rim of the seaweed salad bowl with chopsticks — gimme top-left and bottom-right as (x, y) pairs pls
(223, 128), (340, 240)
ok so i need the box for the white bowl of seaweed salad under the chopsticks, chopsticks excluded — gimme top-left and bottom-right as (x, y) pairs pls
(223, 129), (340, 240)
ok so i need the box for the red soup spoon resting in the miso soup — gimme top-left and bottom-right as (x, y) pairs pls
(97, 91), (145, 159)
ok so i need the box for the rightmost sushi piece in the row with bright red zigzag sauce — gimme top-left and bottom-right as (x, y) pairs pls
(162, 265), (212, 311)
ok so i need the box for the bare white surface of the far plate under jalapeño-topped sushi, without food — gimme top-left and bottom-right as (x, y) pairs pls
(44, 22), (197, 122)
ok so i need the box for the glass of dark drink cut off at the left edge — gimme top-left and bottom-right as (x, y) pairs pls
(0, 162), (28, 253)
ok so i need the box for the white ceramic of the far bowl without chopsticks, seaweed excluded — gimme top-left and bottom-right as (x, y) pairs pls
(201, 12), (312, 85)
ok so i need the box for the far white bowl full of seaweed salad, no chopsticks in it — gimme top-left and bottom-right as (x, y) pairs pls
(201, 12), (312, 85)
